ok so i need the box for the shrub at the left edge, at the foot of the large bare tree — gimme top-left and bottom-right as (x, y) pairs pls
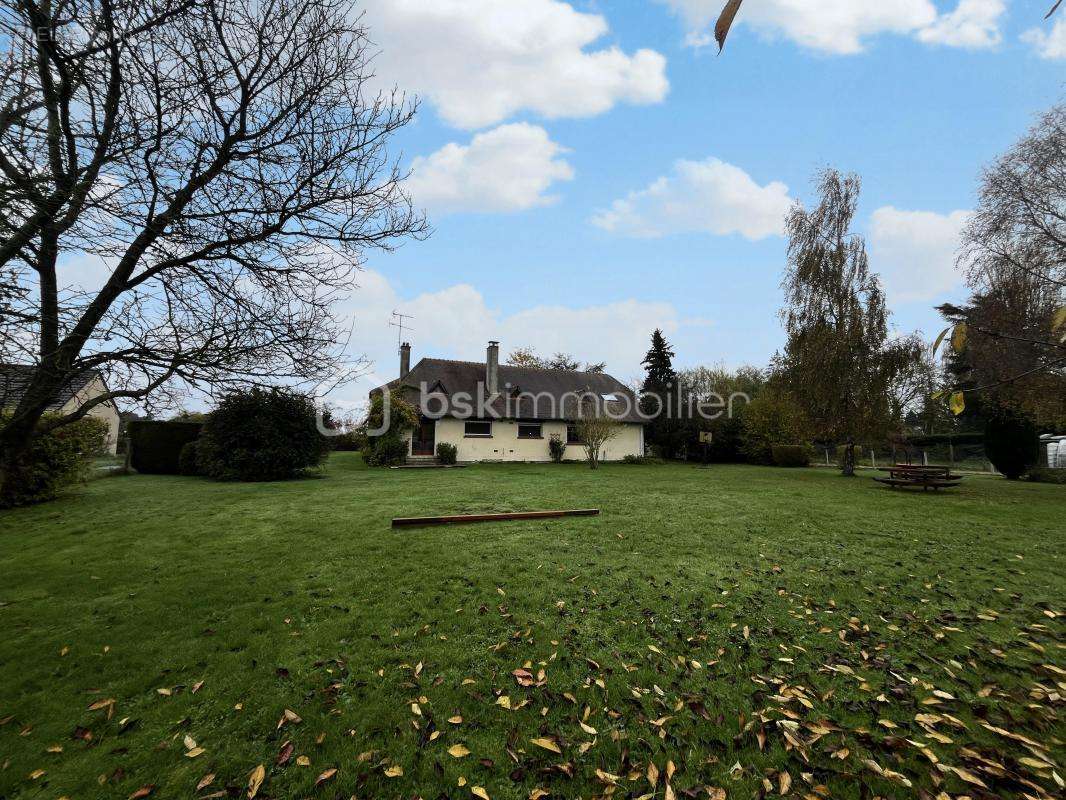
(0, 415), (108, 508)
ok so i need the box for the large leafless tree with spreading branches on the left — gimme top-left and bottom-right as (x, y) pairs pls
(0, 0), (426, 492)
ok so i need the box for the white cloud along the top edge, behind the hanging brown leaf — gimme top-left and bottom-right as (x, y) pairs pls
(659, 0), (1005, 54)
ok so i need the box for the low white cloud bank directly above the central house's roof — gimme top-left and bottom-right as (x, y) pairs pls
(329, 270), (695, 405)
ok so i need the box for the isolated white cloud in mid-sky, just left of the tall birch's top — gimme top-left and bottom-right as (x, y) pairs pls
(592, 158), (792, 241)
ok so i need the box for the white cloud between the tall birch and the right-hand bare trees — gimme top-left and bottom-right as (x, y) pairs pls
(869, 206), (970, 302)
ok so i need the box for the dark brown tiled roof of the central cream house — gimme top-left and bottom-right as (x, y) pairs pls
(371, 358), (647, 423)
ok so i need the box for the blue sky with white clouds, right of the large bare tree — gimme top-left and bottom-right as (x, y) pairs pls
(328, 0), (1066, 391)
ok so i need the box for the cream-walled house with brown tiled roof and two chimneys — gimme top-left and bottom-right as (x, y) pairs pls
(371, 341), (645, 462)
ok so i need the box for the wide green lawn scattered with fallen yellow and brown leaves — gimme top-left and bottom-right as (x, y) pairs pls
(0, 454), (1066, 800)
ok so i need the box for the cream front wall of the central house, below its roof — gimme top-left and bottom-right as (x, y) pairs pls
(422, 417), (644, 462)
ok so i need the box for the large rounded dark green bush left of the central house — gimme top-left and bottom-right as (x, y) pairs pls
(199, 388), (330, 481)
